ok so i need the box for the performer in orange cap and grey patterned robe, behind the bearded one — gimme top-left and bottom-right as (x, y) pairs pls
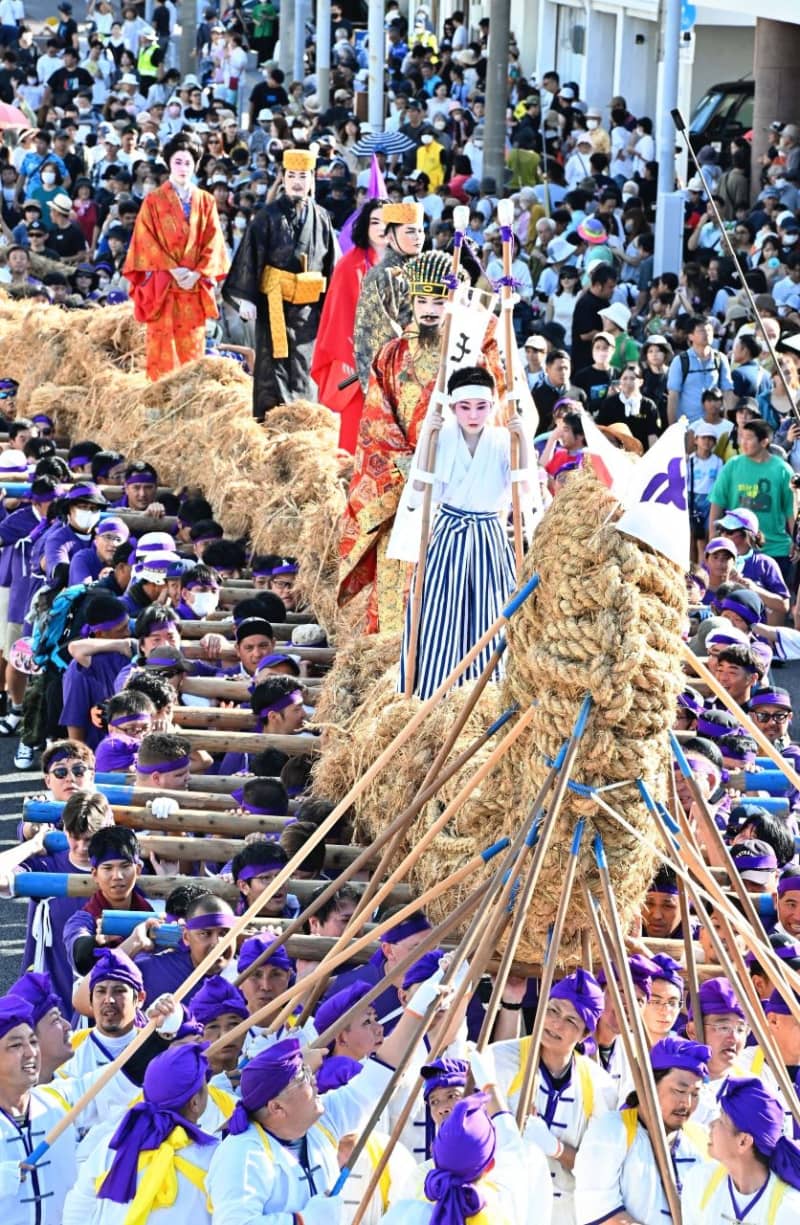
(353, 201), (425, 393)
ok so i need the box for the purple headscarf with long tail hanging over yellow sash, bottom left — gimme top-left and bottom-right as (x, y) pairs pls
(97, 1042), (217, 1204)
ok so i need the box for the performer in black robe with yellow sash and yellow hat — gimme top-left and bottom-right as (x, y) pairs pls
(222, 149), (336, 421)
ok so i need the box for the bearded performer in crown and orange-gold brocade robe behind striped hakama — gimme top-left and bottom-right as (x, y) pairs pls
(338, 251), (506, 633)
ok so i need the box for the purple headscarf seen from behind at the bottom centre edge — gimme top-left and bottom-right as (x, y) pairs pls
(425, 1093), (497, 1225)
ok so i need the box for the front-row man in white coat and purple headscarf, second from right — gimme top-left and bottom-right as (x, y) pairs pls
(575, 1035), (719, 1225)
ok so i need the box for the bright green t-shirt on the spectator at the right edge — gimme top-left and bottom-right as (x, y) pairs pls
(711, 456), (794, 557)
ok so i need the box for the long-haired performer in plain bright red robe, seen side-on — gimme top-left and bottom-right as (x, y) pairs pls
(311, 200), (386, 454)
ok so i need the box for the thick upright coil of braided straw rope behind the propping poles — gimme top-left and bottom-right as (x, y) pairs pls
(492, 469), (686, 960)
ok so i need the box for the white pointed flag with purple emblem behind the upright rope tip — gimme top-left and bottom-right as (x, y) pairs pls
(615, 419), (691, 568)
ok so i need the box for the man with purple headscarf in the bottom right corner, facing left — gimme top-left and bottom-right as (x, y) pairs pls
(681, 1077), (800, 1225)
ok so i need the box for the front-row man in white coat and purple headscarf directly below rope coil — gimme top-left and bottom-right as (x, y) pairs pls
(489, 969), (616, 1221)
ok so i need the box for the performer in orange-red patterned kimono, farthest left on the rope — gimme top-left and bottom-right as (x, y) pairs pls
(123, 132), (228, 381)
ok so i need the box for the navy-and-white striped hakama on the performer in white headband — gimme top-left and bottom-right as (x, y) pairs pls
(398, 505), (516, 699)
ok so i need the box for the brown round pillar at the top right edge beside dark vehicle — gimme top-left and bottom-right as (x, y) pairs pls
(752, 17), (800, 200)
